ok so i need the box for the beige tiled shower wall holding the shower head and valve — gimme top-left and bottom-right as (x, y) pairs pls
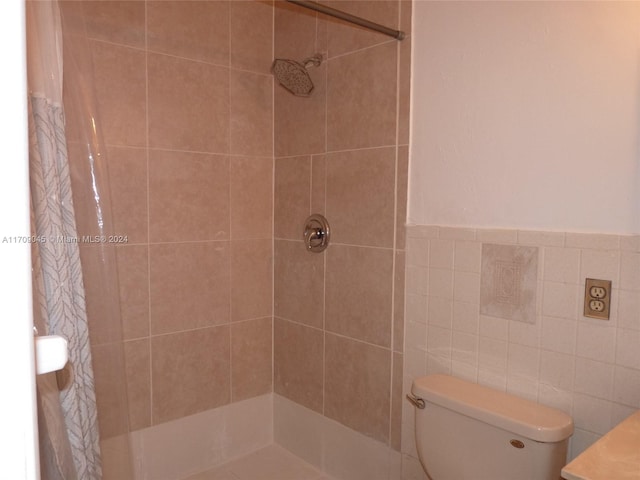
(274, 0), (411, 450)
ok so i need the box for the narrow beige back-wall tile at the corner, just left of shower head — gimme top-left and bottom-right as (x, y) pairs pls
(229, 70), (273, 156)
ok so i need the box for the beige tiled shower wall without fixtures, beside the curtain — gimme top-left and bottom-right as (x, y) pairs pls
(64, 1), (273, 438)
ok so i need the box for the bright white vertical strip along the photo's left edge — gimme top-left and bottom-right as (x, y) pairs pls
(0, 0), (40, 480)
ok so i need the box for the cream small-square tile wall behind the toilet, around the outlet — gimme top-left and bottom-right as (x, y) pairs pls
(402, 225), (640, 479)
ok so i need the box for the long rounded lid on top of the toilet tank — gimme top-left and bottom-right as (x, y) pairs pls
(411, 375), (573, 443)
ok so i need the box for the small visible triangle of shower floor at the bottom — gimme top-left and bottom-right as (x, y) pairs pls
(184, 445), (335, 480)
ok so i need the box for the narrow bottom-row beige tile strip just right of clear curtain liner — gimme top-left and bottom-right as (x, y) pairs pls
(124, 338), (151, 431)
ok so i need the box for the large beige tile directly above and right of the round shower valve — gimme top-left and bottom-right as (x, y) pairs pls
(327, 148), (395, 248)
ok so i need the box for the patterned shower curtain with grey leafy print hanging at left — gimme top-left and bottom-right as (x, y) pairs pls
(26, 0), (102, 480)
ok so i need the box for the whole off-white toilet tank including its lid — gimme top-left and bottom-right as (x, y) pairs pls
(411, 375), (573, 480)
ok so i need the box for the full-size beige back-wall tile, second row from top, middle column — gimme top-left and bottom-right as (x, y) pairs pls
(147, 54), (229, 153)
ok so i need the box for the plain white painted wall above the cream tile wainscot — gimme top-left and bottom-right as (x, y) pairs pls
(408, 0), (640, 233)
